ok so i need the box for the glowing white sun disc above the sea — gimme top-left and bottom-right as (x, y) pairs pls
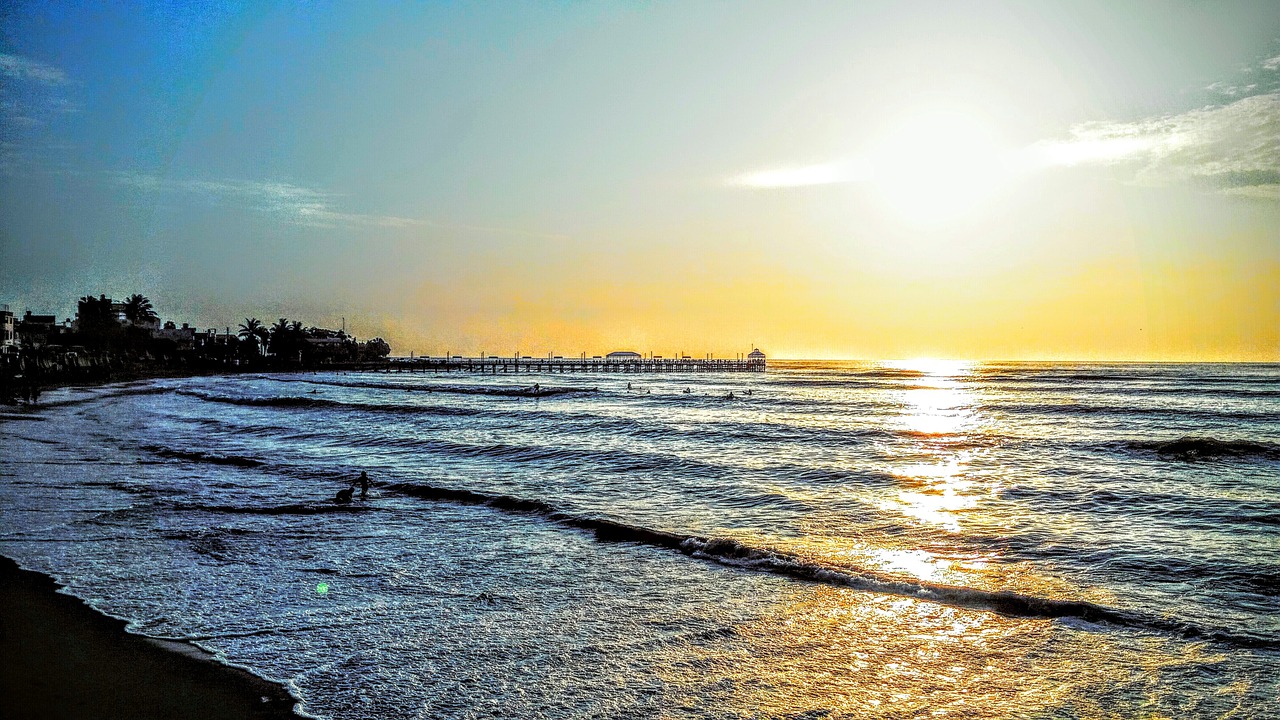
(867, 109), (1012, 225)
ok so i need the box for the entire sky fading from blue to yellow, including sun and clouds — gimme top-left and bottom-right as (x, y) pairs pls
(0, 0), (1280, 361)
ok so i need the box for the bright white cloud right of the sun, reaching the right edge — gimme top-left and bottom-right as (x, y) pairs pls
(1032, 56), (1280, 200)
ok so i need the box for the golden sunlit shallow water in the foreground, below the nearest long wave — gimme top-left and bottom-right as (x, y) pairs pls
(658, 587), (1215, 719)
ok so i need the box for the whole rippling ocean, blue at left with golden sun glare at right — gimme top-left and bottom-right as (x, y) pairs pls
(0, 361), (1280, 719)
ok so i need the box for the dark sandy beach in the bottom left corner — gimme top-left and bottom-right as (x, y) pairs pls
(0, 557), (297, 720)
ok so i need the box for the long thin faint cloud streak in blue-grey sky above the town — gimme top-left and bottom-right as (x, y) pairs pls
(111, 172), (563, 238)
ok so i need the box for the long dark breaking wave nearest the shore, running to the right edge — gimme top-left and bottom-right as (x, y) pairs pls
(381, 483), (1280, 650)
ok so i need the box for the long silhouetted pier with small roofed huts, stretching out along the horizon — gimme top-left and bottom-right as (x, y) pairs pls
(378, 357), (765, 375)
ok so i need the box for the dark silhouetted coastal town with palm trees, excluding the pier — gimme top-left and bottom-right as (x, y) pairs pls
(0, 293), (390, 404)
